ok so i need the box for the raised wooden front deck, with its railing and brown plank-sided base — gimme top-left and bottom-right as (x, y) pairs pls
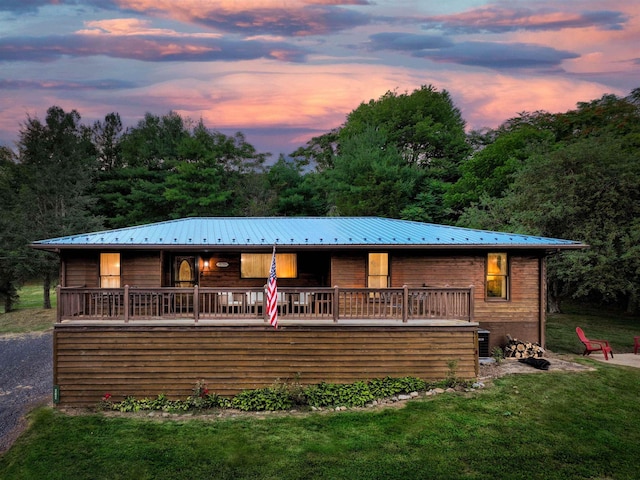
(54, 287), (478, 407)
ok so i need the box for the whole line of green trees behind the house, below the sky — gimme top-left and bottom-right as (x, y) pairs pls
(0, 85), (640, 313)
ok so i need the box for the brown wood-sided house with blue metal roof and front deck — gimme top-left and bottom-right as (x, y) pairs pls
(32, 217), (586, 406)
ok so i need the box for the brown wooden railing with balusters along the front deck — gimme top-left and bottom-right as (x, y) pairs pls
(57, 286), (473, 323)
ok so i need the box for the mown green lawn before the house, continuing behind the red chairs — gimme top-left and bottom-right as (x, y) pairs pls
(0, 300), (640, 480)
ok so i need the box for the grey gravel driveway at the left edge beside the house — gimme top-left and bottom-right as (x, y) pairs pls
(0, 332), (53, 453)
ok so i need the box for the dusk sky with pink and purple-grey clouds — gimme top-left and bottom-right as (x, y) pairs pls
(0, 0), (640, 159)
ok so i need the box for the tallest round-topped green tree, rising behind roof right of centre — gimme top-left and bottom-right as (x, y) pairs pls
(293, 86), (471, 223)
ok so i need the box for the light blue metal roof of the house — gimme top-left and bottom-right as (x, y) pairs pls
(32, 217), (586, 250)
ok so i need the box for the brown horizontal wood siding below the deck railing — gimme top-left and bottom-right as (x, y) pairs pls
(54, 326), (478, 407)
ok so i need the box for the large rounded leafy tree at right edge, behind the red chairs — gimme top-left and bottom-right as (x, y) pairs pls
(512, 137), (640, 312)
